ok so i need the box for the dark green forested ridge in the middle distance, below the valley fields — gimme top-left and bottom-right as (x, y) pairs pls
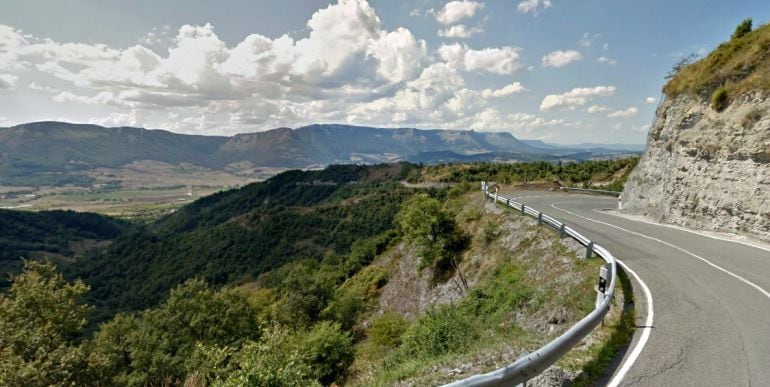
(65, 164), (414, 318)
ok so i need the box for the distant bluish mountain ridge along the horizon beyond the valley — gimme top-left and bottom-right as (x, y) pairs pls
(0, 121), (640, 185)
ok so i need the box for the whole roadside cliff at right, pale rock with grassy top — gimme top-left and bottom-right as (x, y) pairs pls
(623, 19), (770, 240)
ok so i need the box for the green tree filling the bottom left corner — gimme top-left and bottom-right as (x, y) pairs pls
(0, 261), (90, 386)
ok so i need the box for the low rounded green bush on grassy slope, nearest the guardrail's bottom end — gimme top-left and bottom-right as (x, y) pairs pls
(403, 305), (479, 358)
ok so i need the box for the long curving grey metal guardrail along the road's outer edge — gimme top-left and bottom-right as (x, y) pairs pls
(446, 182), (617, 387)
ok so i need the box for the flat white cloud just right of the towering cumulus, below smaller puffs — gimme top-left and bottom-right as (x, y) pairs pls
(438, 43), (523, 74)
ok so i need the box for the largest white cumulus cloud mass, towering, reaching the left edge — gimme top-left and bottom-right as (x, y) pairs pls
(0, 0), (430, 132)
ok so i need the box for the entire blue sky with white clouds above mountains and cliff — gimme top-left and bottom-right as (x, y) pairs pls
(0, 0), (770, 144)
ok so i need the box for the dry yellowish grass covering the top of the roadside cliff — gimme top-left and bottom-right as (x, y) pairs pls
(663, 25), (770, 98)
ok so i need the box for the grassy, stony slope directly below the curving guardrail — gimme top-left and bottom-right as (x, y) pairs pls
(349, 192), (633, 386)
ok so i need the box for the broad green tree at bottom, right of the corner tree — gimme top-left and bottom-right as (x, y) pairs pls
(89, 279), (260, 385)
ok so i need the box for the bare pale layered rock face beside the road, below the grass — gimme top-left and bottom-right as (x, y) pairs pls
(622, 92), (770, 241)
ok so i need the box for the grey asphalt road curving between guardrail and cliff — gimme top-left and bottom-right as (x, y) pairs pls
(501, 191), (770, 386)
